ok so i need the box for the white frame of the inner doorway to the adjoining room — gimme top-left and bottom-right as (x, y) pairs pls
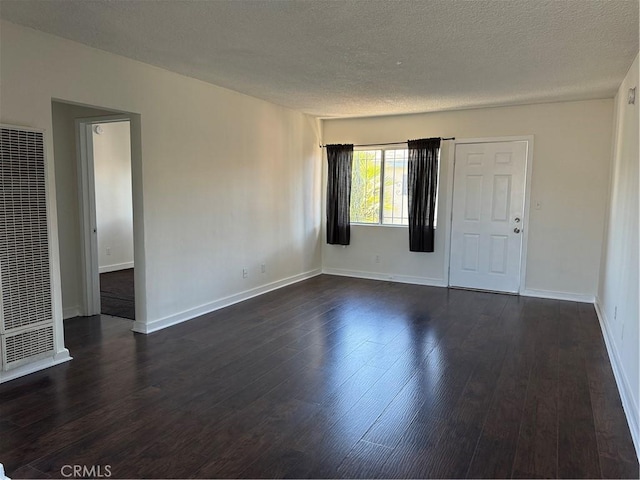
(75, 115), (136, 316)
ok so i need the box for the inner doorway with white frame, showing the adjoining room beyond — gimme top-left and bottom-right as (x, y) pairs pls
(76, 115), (136, 320)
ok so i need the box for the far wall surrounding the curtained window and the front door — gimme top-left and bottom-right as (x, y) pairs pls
(323, 99), (613, 301)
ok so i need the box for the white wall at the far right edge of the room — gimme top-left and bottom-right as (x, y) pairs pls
(596, 52), (640, 456)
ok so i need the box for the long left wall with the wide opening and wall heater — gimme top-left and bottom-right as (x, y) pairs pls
(0, 21), (321, 331)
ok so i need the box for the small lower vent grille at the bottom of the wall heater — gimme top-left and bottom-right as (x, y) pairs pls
(2, 324), (54, 370)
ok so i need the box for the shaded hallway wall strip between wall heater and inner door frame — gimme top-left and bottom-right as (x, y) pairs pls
(50, 101), (119, 318)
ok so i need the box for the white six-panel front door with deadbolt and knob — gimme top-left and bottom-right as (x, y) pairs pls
(449, 141), (528, 293)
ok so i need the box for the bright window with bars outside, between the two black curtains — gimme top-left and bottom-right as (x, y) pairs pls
(350, 149), (439, 225)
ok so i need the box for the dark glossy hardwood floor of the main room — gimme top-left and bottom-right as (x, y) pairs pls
(0, 275), (638, 478)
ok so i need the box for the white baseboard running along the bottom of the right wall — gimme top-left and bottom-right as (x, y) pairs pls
(595, 298), (640, 461)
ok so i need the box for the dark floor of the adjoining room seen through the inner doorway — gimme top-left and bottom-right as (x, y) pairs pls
(100, 268), (136, 320)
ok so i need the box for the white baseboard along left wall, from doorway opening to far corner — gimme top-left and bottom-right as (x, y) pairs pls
(132, 268), (322, 334)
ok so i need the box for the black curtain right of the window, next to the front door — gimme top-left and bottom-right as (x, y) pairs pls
(407, 138), (440, 252)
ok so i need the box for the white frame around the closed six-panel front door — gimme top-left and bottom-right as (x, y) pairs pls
(444, 135), (533, 295)
